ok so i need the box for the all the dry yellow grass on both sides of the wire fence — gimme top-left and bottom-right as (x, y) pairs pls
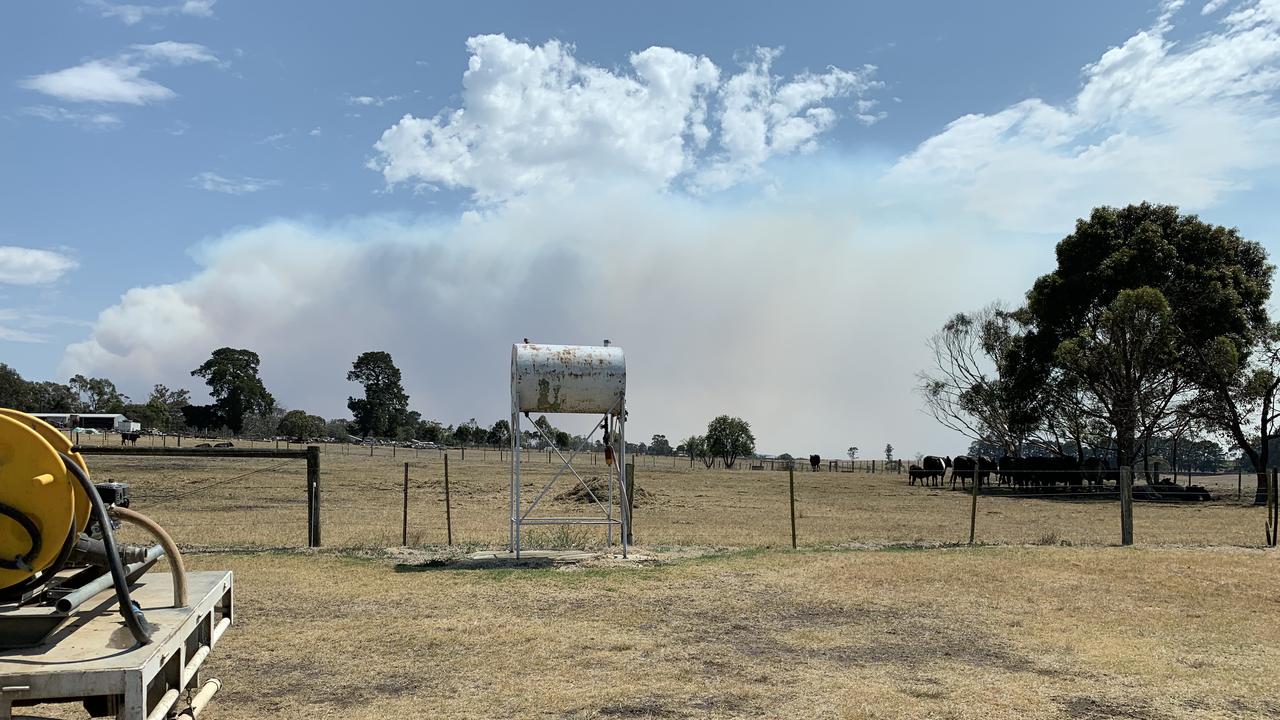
(17, 446), (1280, 720)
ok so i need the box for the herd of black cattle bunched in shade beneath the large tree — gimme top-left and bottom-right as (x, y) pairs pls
(908, 455), (1210, 500)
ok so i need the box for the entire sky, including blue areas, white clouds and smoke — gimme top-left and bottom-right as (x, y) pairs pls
(0, 0), (1280, 454)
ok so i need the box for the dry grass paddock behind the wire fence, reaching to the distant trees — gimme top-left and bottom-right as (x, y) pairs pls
(77, 441), (1267, 548)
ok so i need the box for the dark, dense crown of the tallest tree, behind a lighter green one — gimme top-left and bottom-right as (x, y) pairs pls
(1002, 202), (1274, 474)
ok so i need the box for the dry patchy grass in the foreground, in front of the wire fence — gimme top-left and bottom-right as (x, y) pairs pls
(22, 547), (1280, 720)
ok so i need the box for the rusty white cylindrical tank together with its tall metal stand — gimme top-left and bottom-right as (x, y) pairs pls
(509, 341), (631, 559)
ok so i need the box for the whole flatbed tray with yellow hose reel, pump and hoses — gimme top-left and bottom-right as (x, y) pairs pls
(0, 409), (233, 720)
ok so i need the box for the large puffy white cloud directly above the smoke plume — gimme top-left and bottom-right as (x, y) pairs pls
(357, 35), (876, 201)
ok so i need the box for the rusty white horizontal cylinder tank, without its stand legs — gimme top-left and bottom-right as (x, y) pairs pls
(511, 342), (627, 413)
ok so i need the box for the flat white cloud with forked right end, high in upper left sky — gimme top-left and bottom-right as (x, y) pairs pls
(18, 41), (218, 105)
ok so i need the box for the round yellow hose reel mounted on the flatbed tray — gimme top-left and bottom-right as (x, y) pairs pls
(0, 409), (91, 593)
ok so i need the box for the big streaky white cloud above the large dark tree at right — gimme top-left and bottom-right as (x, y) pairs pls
(892, 0), (1280, 229)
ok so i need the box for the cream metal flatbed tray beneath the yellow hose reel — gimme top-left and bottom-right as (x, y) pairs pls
(0, 570), (233, 720)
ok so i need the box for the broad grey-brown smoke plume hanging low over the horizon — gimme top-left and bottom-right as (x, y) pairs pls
(63, 175), (1047, 456)
